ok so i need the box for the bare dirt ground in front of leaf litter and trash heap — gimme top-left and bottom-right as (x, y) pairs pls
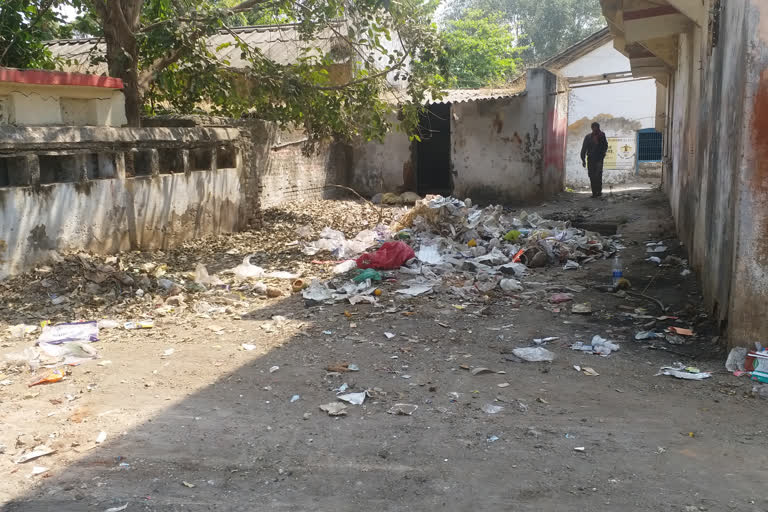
(0, 189), (768, 512)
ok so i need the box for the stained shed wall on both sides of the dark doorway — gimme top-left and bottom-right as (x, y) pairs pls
(351, 69), (568, 202)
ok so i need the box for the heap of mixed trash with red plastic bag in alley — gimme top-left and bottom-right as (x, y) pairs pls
(303, 196), (622, 304)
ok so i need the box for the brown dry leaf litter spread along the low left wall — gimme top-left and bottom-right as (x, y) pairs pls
(0, 200), (403, 330)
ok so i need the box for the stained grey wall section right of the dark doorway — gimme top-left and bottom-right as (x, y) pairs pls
(451, 69), (568, 202)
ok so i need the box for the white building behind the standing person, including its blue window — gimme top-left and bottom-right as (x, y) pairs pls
(541, 28), (661, 187)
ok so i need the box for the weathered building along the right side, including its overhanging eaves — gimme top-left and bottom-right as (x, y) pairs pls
(601, 0), (768, 346)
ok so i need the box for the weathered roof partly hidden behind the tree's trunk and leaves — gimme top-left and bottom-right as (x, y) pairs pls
(46, 21), (344, 74)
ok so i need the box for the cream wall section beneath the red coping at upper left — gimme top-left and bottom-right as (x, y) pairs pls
(0, 82), (127, 126)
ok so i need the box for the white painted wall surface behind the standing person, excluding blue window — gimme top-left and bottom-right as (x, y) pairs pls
(559, 42), (656, 187)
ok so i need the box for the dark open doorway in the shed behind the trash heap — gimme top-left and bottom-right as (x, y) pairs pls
(416, 103), (453, 195)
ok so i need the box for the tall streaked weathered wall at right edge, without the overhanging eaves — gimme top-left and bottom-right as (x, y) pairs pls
(664, 0), (768, 346)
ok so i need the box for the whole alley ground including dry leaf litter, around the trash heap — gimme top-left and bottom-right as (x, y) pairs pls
(0, 186), (768, 512)
